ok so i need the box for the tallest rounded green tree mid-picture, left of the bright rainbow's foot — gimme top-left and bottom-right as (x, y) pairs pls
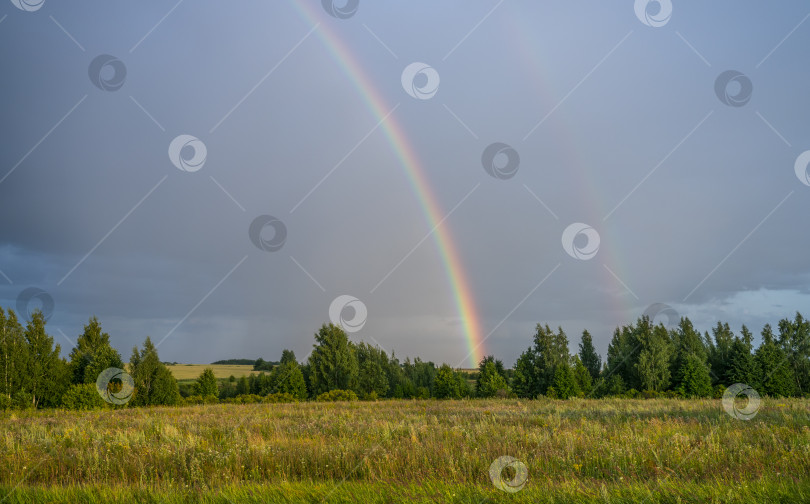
(309, 324), (358, 396)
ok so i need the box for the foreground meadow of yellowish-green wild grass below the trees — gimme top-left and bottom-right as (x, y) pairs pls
(0, 399), (810, 504)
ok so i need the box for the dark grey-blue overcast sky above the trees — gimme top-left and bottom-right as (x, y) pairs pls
(0, 0), (810, 366)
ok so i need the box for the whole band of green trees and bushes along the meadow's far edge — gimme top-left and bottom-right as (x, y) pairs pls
(0, 308), (810, 409)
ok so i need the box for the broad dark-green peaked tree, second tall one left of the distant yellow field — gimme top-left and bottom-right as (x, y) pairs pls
(70, 317), (124, 384)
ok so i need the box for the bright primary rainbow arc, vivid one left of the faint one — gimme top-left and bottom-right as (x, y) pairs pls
(294, 1), (484, 367)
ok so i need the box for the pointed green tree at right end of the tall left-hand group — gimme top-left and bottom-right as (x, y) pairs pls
(129, 336), (180, 406)
